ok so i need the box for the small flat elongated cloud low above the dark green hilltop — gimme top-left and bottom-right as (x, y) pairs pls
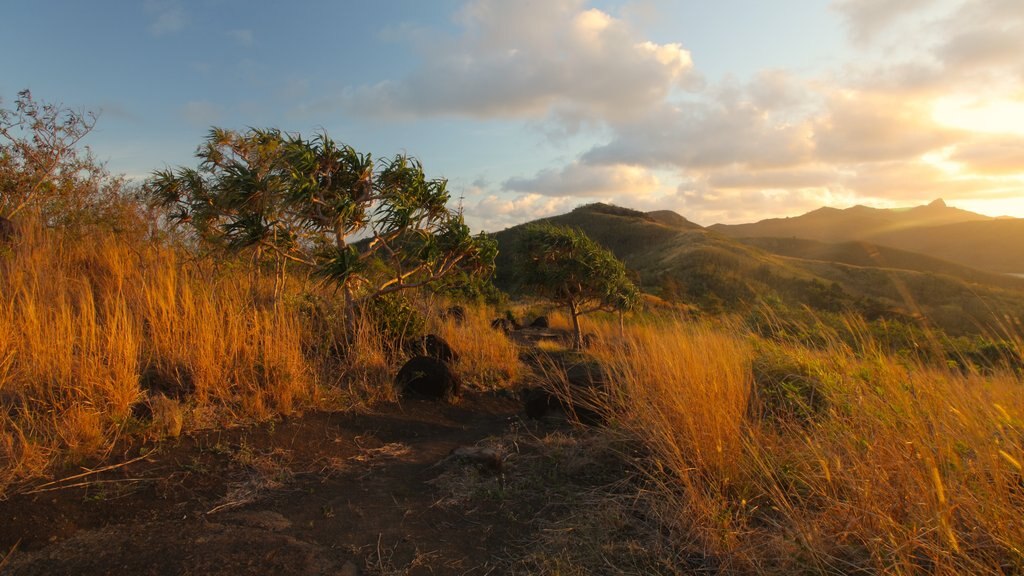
(502, 162), (660, 198)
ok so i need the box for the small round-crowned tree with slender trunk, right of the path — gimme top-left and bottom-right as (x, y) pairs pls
(517, 224), (640, 348)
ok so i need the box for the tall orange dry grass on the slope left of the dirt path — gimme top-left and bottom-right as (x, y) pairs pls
(0, 222), (393, 493)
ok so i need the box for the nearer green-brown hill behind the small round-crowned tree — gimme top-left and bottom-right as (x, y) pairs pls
(494, 204), (1024, 334)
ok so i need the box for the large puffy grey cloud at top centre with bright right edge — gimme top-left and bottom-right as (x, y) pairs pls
(342, 0), (694, 121)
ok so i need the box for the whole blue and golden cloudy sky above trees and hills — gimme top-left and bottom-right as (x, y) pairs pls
(0, 0), (1024, 231)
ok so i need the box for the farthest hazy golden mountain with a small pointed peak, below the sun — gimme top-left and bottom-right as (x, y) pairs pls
(710, 200), (1024, 274)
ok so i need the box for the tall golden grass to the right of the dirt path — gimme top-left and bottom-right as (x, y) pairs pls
(593, 315), (1024, 574)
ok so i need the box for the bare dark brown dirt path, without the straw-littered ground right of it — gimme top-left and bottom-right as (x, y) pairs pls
(0, 393), (544, 576)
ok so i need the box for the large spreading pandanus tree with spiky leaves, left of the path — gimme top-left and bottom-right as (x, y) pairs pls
(147, 128), (497, 328)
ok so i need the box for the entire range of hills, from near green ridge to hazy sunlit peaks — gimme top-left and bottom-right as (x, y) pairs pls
(494, 202), (1024, 334)
